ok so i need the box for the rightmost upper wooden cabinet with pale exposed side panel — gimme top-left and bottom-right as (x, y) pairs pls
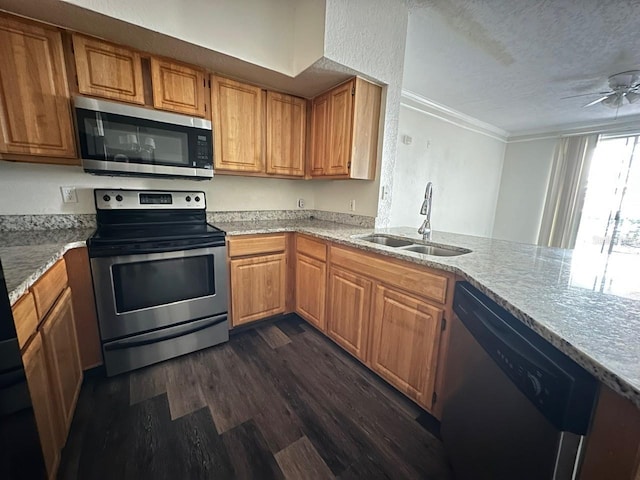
(309, 78), (382, 180)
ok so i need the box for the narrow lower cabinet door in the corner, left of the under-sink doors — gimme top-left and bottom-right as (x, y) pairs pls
(296, 253), (327, 331)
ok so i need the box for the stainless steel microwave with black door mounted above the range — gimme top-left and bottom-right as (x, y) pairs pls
(74, 96), (213, 180)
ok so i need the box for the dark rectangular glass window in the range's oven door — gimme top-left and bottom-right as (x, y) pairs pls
(112, 255), (215, 313)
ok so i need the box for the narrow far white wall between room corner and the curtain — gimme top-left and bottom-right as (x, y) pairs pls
(493, 138), (558, 243)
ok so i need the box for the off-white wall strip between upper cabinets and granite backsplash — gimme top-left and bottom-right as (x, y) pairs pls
(0, 161), (314, 215)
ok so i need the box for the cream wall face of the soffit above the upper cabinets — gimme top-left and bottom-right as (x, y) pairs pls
(63, 0), (324, 76)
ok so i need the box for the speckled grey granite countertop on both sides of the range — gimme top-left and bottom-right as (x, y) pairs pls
(0, 220), (640, 408)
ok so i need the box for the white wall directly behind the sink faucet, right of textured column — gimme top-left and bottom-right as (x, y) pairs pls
(390, 105), (505, 237)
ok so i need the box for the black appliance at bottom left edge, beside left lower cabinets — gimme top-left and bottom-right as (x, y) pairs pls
(0, 263), (46, 480)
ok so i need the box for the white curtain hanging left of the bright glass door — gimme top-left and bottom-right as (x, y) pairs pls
(538, 135), (598, 248)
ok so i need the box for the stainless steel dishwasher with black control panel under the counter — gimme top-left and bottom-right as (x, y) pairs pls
(441, 282), (598, 480)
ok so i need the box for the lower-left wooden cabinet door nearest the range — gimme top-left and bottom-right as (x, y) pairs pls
(42, 287), (82, 445)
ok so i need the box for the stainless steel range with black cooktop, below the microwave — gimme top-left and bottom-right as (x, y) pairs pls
(88, 189), (229, 376)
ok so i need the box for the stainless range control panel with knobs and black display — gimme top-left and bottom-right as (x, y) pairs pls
(93, 189), (207, 210)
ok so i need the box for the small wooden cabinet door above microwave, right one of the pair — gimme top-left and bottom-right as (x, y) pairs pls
(151, 57), (205, 117)
